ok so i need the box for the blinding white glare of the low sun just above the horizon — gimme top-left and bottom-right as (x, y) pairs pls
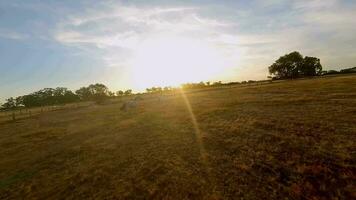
(132, 37), (223, 90)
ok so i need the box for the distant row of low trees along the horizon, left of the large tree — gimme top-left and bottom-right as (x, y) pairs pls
(0, 80), (256, 110)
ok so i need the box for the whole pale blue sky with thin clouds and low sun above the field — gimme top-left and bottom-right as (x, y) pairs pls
(0, 0), (356, 101)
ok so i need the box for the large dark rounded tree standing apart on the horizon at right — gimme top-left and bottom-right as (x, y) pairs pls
(268, 51), (322, 79)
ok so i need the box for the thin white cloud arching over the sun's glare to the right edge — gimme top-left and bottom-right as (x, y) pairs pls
(55, 0), (356, 81)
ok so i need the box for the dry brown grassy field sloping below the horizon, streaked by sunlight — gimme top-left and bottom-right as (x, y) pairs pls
(0, 75), (356, 199)
